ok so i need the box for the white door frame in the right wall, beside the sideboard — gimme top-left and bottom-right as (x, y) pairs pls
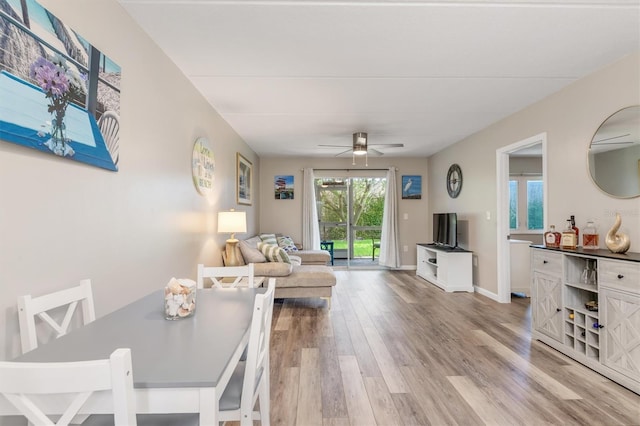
(496, 133), (548, 303)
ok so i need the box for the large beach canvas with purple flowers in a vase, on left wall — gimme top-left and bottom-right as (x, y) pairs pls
(0, 0), (121, 171)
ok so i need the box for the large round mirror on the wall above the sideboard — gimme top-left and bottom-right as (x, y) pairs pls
(589, 106), (640, 198)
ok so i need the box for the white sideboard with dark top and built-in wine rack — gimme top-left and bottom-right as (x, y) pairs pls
(531, 246), (640, 394)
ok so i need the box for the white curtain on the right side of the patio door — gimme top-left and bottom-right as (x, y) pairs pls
(378, 167), (401, 268)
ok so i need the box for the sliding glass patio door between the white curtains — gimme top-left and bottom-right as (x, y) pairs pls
(315, 177), (386, 269)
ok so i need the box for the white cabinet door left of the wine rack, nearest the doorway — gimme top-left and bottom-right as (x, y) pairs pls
(532, 271), (562, 342)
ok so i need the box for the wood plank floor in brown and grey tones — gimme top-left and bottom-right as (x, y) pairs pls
(262, 271), (640, 426)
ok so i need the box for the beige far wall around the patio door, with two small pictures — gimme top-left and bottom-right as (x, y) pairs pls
(260, 157), (430, 267)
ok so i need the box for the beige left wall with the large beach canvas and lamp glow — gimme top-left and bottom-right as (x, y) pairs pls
(0, 0), (259, 359)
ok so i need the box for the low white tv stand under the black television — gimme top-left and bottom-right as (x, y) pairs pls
(416, 244), (473, 293)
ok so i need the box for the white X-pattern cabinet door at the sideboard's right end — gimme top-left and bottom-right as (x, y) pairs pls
(600, 288), (640, 380)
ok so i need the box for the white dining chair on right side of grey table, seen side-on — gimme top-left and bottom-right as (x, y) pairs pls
(219, 278), (276, 426)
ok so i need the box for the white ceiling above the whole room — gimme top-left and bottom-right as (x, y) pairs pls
(119, 0), (640, 157)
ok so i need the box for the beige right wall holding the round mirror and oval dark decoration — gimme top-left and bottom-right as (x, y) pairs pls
(429, 53), (640, 294)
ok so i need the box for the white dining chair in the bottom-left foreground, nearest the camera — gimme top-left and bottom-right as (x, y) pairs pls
(0, 349), (136, 426)
